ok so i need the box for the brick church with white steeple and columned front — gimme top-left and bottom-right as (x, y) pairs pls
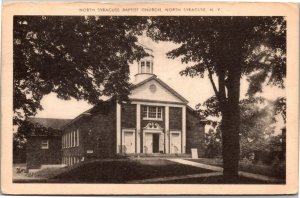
(62, 48), (205, 165)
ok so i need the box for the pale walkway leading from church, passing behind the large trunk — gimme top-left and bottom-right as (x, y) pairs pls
(167, 159), (283, 183)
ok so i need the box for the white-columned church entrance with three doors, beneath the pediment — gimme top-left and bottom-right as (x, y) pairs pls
(116, 101), (186, 154)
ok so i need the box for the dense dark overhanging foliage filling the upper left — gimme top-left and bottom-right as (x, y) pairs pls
(13, 16), (146, 125)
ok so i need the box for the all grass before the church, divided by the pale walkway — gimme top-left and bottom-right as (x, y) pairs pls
(16, 158), (285, 184)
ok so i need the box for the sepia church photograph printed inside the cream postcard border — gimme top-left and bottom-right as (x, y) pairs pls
(2, 2), (298, 194)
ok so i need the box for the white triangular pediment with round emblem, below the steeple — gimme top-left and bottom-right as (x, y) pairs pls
(129, 78), (187, 103)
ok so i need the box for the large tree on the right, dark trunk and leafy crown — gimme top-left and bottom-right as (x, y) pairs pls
(148, 16), (286, 182)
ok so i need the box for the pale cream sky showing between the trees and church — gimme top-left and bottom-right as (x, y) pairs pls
(36, 37), (285, 125)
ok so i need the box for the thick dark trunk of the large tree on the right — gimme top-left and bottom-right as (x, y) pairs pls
(221, 49), (241, 183)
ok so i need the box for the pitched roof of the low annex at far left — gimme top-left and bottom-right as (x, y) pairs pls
(28, 117), (72, 129)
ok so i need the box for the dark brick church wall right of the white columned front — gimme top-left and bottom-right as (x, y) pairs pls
(186, 109), (205, 157)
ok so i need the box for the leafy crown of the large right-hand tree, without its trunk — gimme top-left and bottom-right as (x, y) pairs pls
(148, 16), (286, 100)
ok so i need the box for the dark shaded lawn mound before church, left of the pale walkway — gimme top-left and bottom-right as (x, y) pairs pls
(28, 159), (212, 183)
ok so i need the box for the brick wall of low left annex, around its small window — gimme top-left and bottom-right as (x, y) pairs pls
(26, 136), (62, 169)
